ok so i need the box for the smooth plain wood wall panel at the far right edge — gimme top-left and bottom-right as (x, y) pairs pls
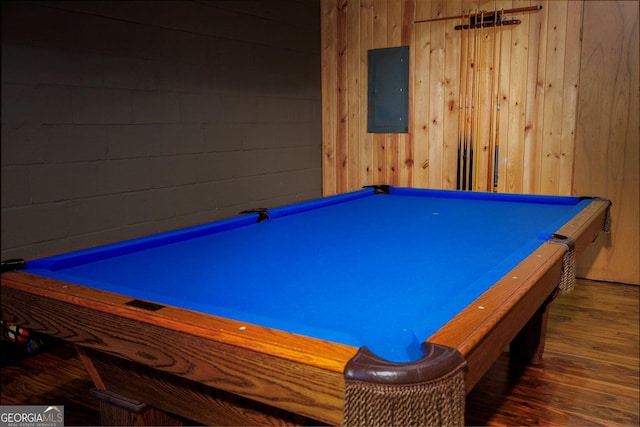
(574, 0), (640, 284)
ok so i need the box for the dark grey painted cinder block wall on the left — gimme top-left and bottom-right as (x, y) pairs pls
(1, 0), (321, 259)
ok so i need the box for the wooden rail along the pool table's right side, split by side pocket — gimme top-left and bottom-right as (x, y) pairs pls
(428, 200), (610, 391)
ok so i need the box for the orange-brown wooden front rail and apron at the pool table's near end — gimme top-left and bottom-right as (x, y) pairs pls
(2, 273), (358, 424)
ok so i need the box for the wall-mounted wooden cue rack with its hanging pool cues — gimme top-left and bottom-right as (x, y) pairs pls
(414, 6), (542, 191)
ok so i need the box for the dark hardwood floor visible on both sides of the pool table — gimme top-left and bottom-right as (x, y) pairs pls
(0, 280), (640, 426)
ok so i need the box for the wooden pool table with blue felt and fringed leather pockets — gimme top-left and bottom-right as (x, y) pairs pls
(1, 186), (610, 425)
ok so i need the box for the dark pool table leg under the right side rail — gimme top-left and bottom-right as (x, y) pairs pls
(509, 288), (558, 365)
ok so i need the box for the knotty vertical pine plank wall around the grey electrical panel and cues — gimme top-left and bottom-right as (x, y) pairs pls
(321, 0), (640, 283)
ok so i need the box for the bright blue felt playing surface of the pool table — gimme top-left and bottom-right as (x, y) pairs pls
(28, 189), (589, 362)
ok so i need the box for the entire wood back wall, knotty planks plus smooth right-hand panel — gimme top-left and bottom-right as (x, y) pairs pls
(320, 0), (640, 283)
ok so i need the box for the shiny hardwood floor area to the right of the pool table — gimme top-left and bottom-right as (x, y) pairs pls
(467, 280), (640, 426)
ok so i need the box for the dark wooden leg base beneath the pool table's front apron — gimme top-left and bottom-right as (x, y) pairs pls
(76, 346), (326, 426)
